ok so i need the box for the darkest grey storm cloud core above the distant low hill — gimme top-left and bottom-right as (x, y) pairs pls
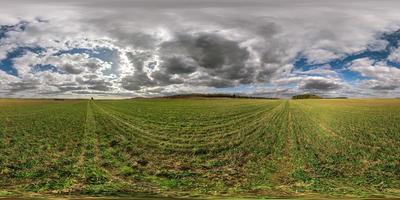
(161, 33), (255, 87)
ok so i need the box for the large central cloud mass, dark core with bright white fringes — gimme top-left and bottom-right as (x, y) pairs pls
(121, 32), (294, 91)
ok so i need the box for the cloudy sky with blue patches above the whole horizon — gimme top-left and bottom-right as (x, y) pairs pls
(0, 0), (400, 98)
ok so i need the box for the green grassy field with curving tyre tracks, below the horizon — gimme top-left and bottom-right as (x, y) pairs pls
(0, 98), (400, 197)
